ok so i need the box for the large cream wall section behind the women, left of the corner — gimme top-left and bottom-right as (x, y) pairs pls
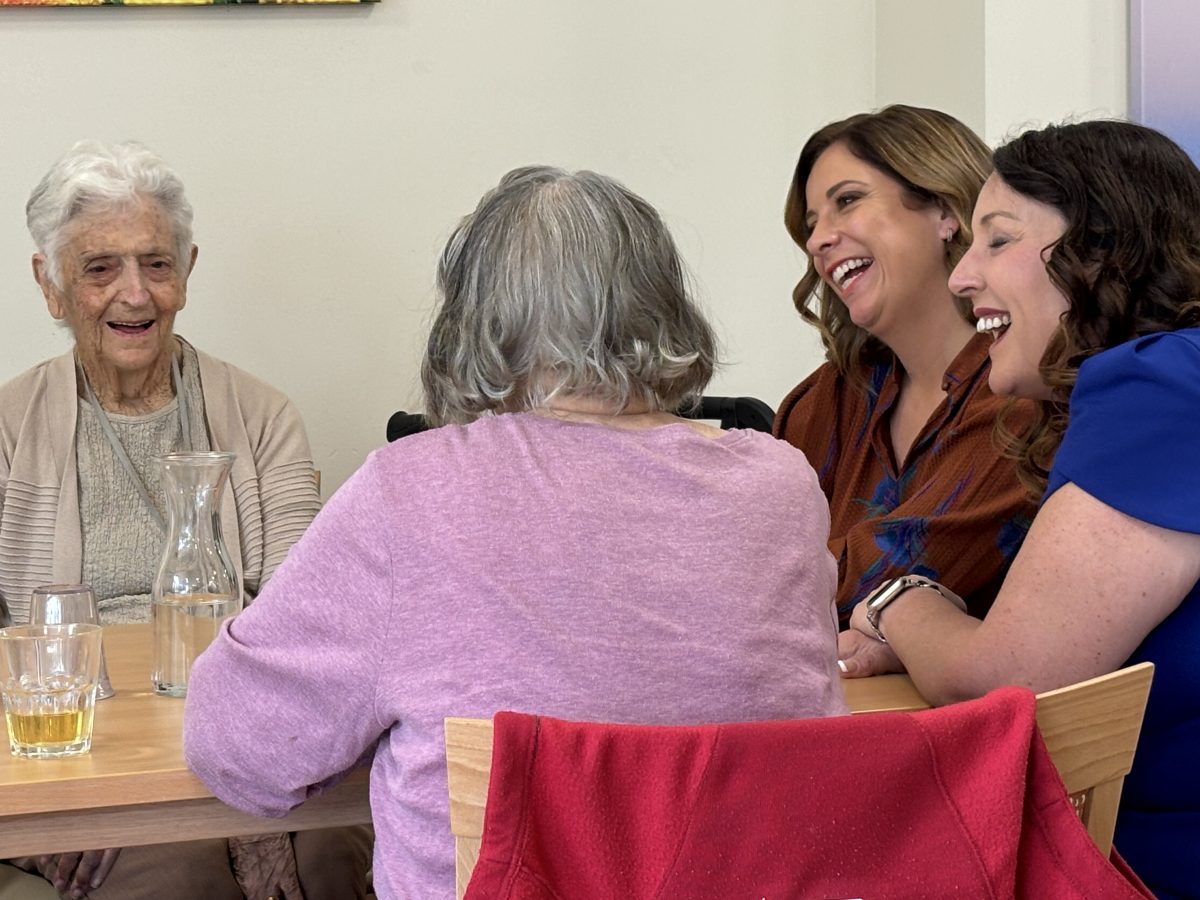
(0, 0), (872, 493)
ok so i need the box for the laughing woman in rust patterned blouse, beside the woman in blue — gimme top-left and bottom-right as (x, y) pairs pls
(775, 106), (1034, 628)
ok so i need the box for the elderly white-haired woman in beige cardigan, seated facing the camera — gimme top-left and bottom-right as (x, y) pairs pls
(0, 142), (368, 900)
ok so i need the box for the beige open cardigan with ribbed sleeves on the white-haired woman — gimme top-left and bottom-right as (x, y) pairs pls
(0, 350), (320, 623)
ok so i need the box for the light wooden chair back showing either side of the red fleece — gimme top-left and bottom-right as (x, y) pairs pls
(445, 662), (1154, 900)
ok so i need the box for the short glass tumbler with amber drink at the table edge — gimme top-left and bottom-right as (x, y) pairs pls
(0, 624), (101, 760)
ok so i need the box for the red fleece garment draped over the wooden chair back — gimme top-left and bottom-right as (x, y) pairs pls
(467, 688), (1151, 900)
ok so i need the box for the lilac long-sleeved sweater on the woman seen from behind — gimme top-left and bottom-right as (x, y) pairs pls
(185, 414), (845, 900)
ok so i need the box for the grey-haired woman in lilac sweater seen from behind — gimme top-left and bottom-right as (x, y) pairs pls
(184, 167), (845, 900)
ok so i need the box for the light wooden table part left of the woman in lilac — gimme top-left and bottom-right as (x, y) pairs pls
(0, 625), (371, 858)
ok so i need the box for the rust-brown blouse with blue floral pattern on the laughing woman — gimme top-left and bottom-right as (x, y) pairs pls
(775, 335), (1037, 628)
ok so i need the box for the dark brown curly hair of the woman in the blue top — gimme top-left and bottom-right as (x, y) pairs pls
(994, 121), (1200, 497)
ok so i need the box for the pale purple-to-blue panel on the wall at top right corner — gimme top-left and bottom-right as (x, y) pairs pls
(1129, 0), (1200, 163)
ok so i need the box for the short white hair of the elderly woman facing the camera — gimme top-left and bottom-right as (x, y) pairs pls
(25, 140), (192, 288)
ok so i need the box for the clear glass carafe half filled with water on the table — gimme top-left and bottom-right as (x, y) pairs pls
(151, 452), (242, 697)
